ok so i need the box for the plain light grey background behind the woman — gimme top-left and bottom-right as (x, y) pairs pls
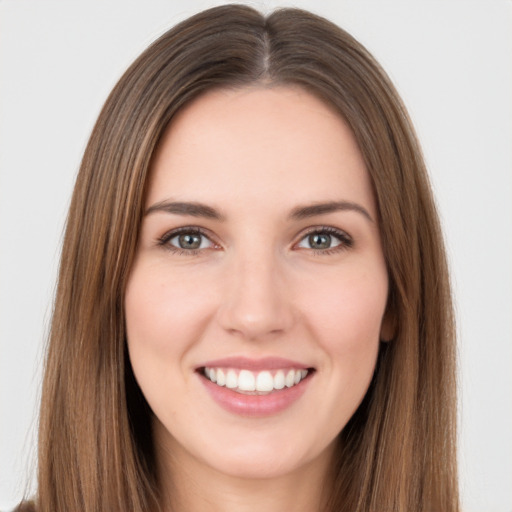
(0, 0), (512, 512)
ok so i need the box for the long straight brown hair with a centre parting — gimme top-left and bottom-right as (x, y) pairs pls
(30, 5), (458, 512)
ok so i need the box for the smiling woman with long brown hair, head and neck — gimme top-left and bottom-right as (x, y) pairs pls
(20, 6), (458, 512)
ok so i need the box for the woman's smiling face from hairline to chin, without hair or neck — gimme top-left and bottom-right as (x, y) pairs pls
(125, 87), (388, 478)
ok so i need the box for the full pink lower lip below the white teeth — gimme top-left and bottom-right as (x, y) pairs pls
(199, 374), (312, 417)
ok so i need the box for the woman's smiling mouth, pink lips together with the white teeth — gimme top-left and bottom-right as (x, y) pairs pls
(197, 358), (315, 416)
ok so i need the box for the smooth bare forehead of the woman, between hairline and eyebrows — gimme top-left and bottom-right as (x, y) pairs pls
(148, 86), (374, 216)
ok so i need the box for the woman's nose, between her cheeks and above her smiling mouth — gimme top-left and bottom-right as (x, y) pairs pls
(218, 248), (294, 340)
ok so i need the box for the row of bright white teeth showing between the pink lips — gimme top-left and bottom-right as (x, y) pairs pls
(204, 368), (309, 394)
